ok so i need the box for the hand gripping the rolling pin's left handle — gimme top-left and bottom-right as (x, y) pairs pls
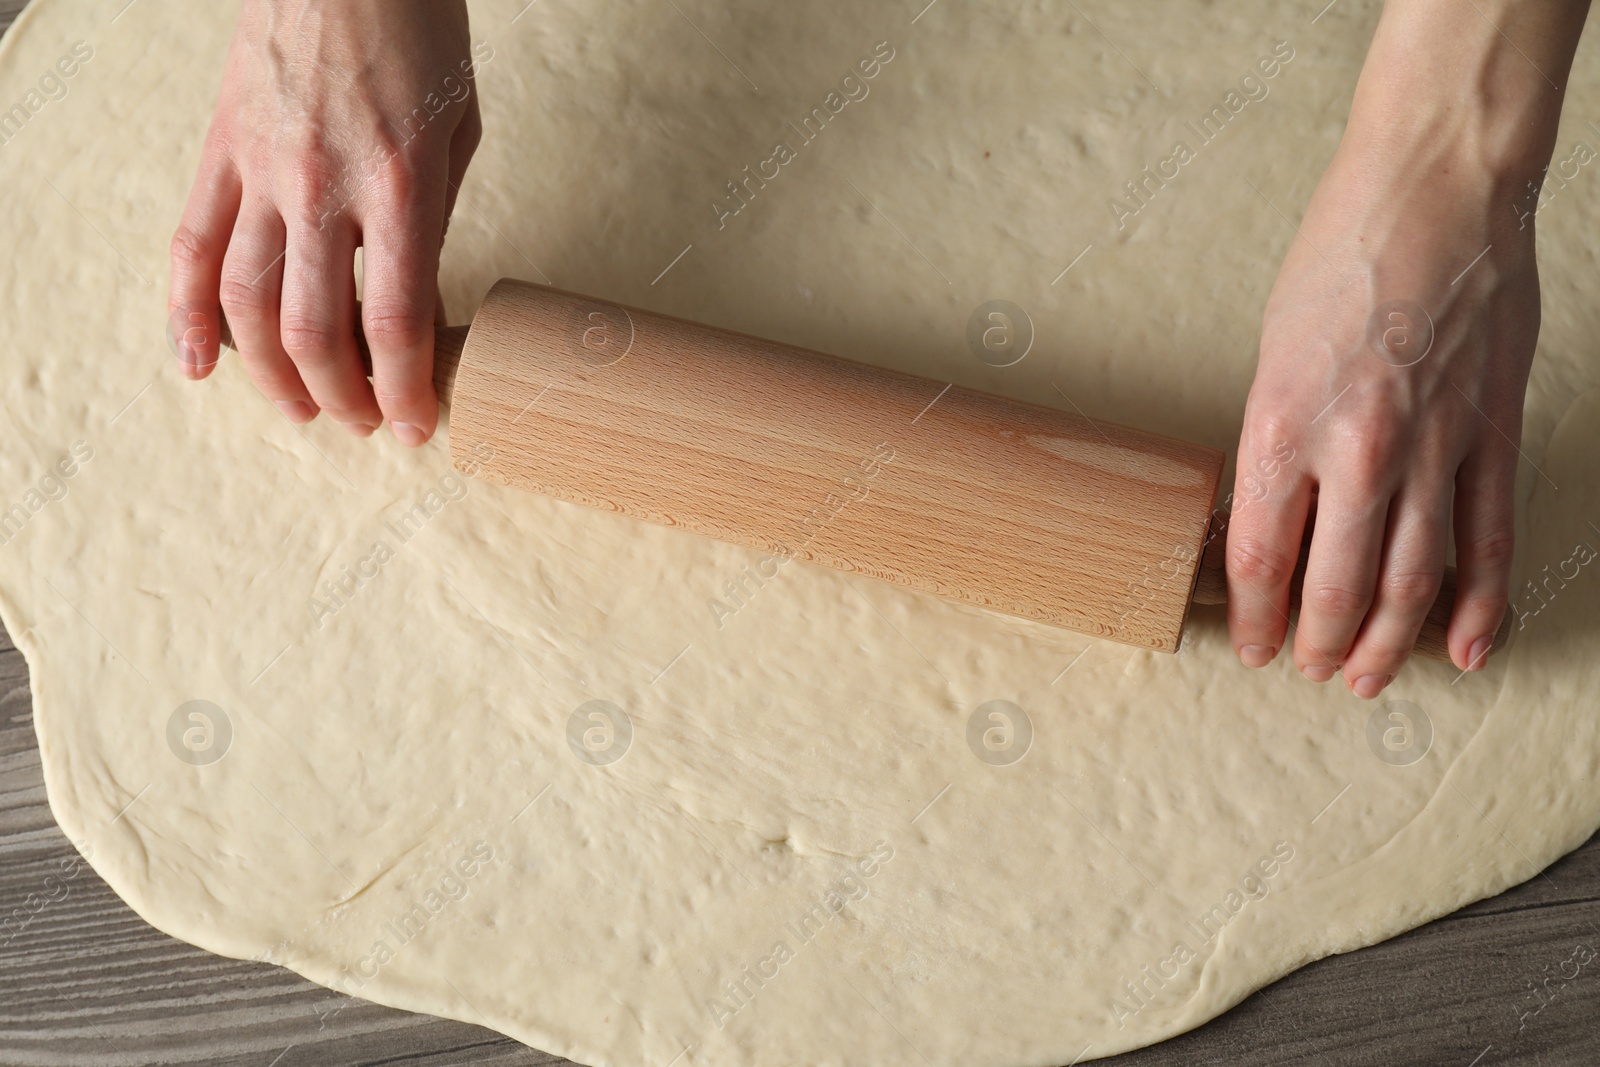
(170, 0), (482, 445)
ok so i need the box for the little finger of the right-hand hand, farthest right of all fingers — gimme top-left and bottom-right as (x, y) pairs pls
(1450, 442), (1517, 670)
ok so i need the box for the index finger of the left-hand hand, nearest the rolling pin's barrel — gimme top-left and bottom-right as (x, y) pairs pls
(362, 174), (445, 446)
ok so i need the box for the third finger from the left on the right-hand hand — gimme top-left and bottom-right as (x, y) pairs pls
(1344, 485), (1450, 701)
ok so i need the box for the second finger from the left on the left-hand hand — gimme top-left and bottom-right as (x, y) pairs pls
(219, 192), (317, 422)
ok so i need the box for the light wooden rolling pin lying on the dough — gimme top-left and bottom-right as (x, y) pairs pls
(416, 280), (1510, 659)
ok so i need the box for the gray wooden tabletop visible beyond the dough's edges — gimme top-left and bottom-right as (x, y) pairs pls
(0, 0), (1600, 1067)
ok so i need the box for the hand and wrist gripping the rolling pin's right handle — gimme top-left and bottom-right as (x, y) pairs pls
(1227, 0), (1587, 697)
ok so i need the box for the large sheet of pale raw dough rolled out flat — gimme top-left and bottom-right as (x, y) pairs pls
(0, 0), (1600, 1067)
